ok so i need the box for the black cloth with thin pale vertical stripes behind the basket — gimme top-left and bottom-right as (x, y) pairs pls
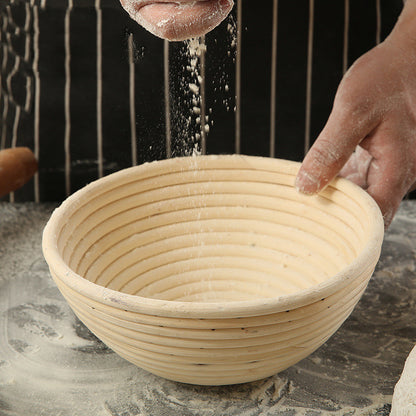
(0, 0), (402, 201)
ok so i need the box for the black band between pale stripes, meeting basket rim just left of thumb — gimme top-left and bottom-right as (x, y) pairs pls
(276, 0), (309, 160)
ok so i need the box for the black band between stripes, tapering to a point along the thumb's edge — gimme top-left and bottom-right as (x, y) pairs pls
(310, 0), (344, 144)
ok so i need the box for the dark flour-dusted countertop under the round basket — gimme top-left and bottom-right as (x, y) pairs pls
(0, 201), (416, 416)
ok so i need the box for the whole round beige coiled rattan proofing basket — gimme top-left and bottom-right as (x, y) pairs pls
(43, 155), (383, 385)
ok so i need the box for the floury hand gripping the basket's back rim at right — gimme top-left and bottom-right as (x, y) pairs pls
(296, 0), (416, 227)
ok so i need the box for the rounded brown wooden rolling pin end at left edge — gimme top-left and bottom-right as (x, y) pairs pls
(0, 147), (38, 197)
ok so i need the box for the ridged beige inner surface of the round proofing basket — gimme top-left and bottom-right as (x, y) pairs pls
(57, 156), (368, 302)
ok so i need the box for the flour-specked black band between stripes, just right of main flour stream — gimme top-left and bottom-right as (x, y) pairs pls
(206, 13), (237, 154)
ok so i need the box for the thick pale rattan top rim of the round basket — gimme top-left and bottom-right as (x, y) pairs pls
(42, 155), (384, 319)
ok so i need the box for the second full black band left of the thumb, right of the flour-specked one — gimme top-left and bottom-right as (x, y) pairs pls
(240, 0), (273, 156)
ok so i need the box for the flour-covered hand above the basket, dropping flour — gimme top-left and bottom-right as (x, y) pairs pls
(120, 0), (234, 41)
